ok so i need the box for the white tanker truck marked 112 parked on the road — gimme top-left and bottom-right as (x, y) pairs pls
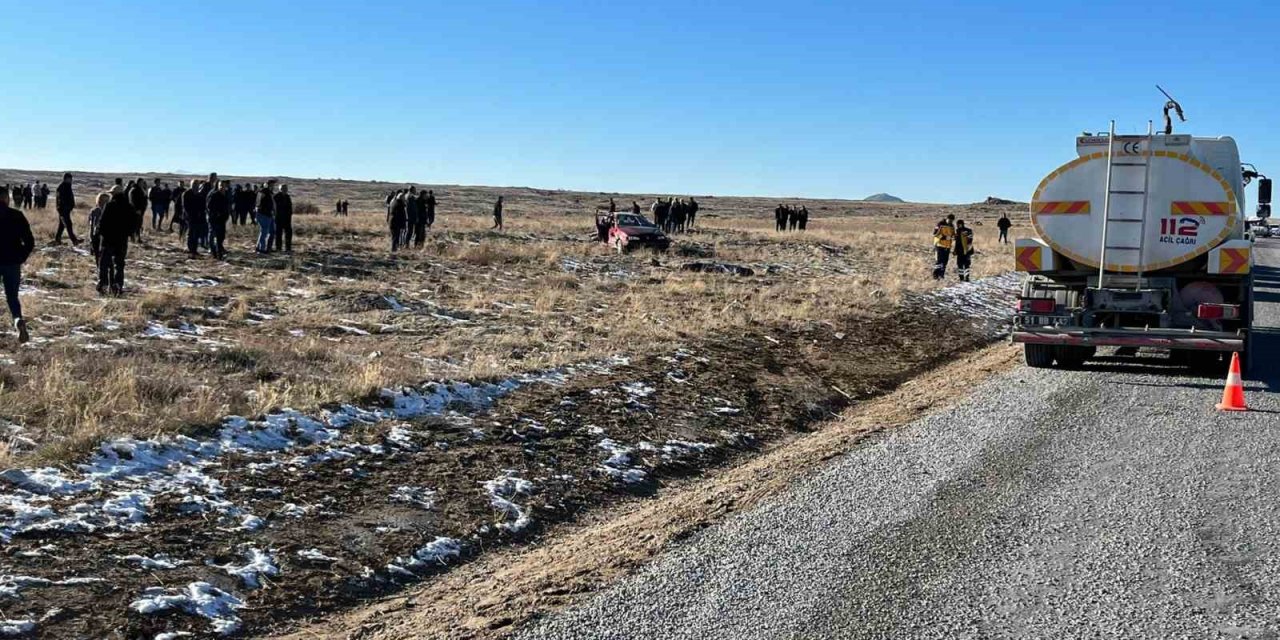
(1011, 120), (1271, 369)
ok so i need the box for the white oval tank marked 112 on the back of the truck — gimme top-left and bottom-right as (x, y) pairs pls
(1032, 136), (1244, 273)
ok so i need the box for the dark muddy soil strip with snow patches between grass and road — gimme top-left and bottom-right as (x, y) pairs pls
(0, 277), (1018, 637)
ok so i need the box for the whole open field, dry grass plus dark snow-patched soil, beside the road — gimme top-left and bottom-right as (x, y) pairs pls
(0, 172), (1021, 637)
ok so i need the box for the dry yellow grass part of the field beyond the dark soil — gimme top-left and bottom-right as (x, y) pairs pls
(0, 172), (1011, 465)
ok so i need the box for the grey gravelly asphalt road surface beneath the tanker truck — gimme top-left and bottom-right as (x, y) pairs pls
(520, 241), (1280, 640)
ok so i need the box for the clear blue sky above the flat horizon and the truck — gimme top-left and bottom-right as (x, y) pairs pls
(0, 0), (1280, 202)
